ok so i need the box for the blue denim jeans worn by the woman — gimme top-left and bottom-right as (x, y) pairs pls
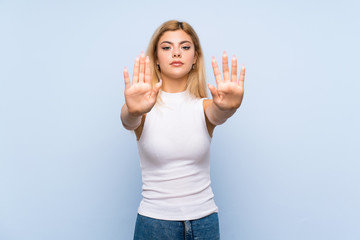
(134, 213), (220, 240)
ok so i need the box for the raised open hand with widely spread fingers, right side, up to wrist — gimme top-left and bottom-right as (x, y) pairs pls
(208, 52), (245, 111)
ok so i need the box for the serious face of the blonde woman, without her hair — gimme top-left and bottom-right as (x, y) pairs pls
(157, 30), (196, 79)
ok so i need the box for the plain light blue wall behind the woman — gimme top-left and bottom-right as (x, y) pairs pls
(0, 0), (360, 240)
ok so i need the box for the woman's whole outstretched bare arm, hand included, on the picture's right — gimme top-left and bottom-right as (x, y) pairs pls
(205, 52), (245, 125)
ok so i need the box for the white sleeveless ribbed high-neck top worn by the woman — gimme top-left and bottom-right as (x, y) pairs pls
(138, 91), (218, 221)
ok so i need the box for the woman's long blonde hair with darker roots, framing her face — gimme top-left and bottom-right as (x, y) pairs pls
(146, 20), (207, 98)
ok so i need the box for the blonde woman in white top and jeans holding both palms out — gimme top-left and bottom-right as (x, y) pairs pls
(121, 20), (245, 240)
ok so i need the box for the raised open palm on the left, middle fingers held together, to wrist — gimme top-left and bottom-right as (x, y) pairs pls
(124, 54), (161, 117)
